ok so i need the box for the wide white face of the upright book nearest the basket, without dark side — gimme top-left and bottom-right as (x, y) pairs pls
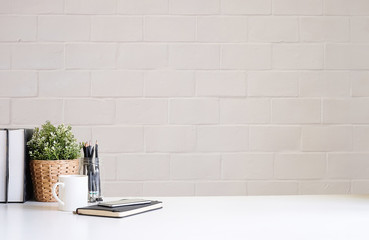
(8, 129), (26, 202)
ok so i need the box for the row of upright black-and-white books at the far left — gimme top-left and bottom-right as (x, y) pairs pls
(0, 129), (33, 203)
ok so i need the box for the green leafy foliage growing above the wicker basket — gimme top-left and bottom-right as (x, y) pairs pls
(27, 121), (81, 160)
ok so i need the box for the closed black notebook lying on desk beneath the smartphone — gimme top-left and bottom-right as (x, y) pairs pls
(76, 201), (163, 218)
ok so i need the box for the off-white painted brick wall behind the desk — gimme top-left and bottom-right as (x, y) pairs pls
(0, 0), (369, 196)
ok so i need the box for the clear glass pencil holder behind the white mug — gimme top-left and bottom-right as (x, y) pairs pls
(80, 157), (102, 202)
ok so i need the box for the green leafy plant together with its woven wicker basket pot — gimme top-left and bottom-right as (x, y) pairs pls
(27, 121), (81, 202)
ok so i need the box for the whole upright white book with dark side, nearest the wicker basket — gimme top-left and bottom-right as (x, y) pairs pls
(5, 129), (33, 202)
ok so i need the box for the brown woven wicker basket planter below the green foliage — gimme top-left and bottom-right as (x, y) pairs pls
(30, 159), (79, 202)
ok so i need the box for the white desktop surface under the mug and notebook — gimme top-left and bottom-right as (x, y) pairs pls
(0, 196), (369, 240)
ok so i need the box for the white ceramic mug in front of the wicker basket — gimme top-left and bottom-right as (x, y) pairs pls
(52, 175), (88, 212)
